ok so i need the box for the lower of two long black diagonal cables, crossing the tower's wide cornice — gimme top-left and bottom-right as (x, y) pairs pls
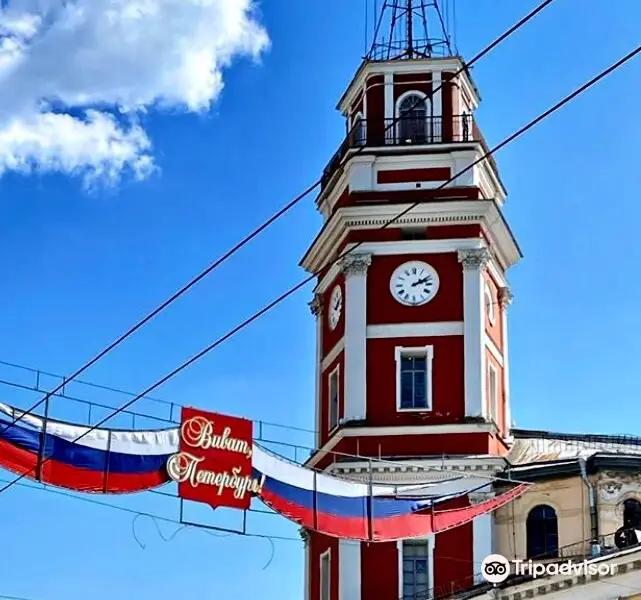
(0, 39), (641, 493)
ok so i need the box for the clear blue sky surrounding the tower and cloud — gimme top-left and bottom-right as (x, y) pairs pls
(0, 0), (641, 600)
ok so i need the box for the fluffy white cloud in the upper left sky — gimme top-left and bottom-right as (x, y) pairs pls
(0, 0), (269, 184)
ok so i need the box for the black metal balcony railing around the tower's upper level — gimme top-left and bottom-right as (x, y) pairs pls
(322, 115), (486, 187)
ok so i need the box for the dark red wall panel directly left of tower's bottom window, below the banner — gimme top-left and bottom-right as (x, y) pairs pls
(361, 542), (398, 600)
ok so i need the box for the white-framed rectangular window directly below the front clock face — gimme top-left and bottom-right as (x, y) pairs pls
(396, 346), (433, 410)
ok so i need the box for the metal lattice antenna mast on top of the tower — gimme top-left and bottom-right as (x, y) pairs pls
(366, 0), (453, 60)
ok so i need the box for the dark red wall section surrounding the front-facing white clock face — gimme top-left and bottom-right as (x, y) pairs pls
(367, 252), (463, 324)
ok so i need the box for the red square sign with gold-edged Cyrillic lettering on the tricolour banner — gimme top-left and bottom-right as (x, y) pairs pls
(167, 407), (262, 510)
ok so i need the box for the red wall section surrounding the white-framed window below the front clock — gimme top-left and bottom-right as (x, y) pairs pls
(367, 335), (465, 426)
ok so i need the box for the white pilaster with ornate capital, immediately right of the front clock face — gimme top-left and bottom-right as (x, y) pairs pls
(458, 248), (490, 417)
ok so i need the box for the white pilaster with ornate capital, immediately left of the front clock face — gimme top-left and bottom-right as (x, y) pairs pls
(341, 254), (372, 421)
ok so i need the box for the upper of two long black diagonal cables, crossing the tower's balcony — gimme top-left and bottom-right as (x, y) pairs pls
(3, 0), (554, 431)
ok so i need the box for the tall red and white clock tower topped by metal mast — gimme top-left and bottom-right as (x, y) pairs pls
(301, 0), (521, 600)
